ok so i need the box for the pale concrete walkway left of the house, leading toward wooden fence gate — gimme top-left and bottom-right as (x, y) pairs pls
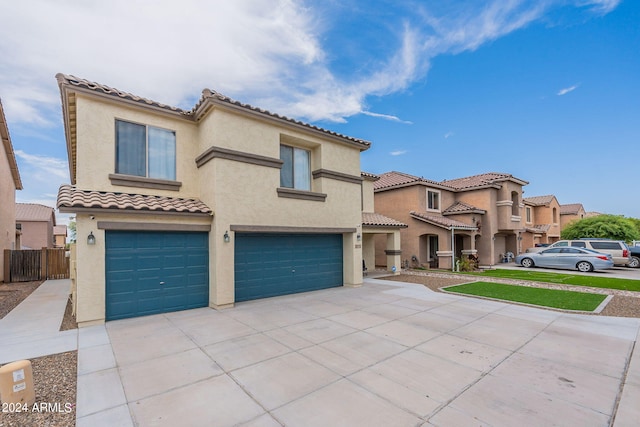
(0, 279), (78, 363)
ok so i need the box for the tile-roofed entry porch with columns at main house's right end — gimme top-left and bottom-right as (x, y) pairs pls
(357, 172), (407, 272)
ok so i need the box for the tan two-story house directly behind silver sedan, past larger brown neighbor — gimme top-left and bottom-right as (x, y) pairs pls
(519, 195), (562, 252)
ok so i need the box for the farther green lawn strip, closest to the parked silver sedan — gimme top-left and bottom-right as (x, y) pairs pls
(464, 269), (640, 292)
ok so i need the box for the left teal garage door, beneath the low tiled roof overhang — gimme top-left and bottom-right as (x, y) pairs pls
(106, 231), (209, 320)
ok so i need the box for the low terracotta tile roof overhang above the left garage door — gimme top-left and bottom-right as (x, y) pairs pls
(58, 184), (213, 215)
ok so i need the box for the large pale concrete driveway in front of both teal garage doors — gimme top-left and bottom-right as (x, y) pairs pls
(77, 279), (640, 427)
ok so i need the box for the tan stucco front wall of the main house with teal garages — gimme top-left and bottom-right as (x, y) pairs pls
(71, 96), (362, 325)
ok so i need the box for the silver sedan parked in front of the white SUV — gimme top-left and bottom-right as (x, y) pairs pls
(516, 247), (613, 272)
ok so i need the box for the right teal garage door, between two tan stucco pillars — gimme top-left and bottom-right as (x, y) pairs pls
(235, 233), (343, 301)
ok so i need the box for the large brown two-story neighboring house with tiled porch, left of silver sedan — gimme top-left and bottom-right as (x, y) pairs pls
(374, 172), (528, 269)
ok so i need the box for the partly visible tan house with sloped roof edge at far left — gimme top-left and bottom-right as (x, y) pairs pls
(0, 100), (22, 281)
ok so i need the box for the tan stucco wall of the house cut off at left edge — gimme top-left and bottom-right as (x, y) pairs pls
(0, 148), (19, 281)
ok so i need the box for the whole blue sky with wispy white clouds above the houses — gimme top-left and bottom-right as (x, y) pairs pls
(0, 0), (640, 222)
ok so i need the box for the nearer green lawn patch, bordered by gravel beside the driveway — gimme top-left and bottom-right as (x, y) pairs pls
(444, 282), (607, 311)
